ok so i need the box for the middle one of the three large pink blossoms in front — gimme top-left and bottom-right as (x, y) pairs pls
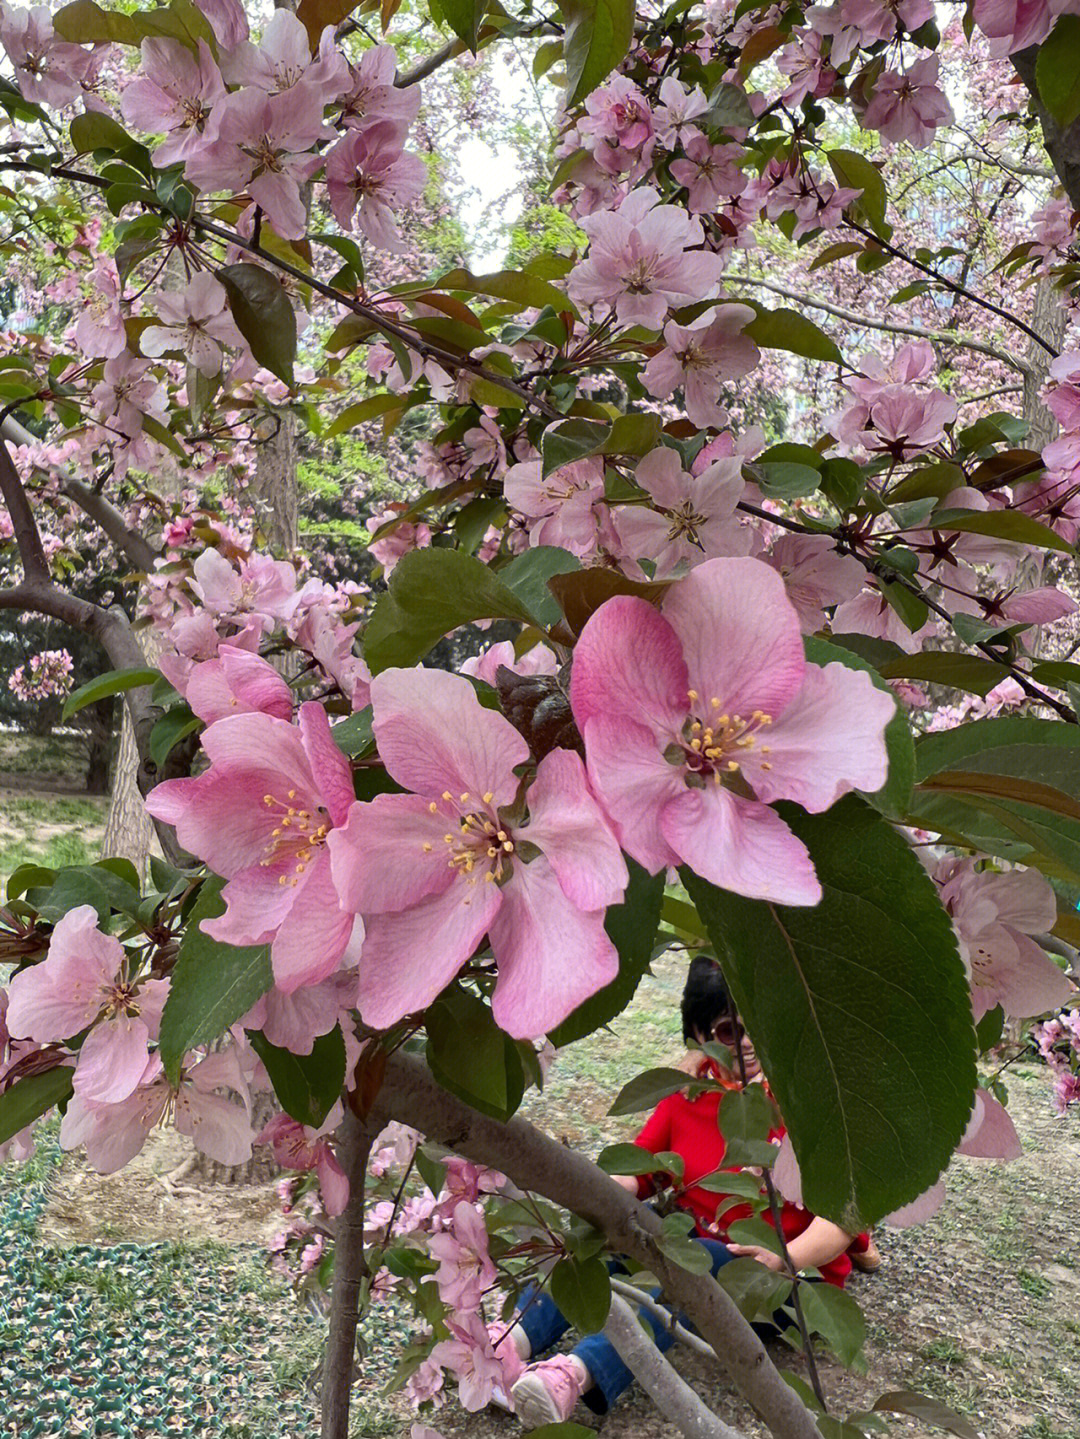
(329, 669), (627, 1039)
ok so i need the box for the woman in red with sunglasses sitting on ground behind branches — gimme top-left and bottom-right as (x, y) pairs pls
(500, 955), (854, 1429)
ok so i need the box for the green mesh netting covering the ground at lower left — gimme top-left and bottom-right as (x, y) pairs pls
(0, 1140), (322, 1439)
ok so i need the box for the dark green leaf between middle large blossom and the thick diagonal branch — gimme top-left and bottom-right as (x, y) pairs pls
(426, 984), (525, 1120)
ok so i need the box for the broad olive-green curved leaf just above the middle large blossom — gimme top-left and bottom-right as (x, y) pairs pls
(364, 550), (538, 675)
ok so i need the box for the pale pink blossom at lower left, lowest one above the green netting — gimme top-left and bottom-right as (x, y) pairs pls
(60, 1050), (252, 1174)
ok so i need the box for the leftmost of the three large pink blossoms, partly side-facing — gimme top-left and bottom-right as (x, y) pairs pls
(147, 701), (354, 994)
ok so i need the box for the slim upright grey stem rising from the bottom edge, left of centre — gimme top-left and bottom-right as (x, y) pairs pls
(321, 1107), (377, 1439)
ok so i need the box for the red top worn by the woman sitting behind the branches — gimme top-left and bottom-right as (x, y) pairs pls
(634, 1085), (851, 1288)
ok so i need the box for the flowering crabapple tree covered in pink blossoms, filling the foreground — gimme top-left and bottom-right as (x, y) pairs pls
(0, 0), (1080, 1439)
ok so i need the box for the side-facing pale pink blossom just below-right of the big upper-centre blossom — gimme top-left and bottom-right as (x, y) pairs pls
(641, 305), (761, 429)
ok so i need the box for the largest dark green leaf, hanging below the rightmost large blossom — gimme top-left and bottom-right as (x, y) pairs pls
(680, 796), (975, 1233)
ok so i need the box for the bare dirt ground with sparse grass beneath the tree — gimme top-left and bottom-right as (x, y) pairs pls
(25, 958), (1080, 1439)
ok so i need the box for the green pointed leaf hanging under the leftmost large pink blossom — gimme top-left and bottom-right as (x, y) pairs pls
(161, 875), (273, 1084)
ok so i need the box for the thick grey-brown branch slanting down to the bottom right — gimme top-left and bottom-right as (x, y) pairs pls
(368, 1052), (821, 1439)
